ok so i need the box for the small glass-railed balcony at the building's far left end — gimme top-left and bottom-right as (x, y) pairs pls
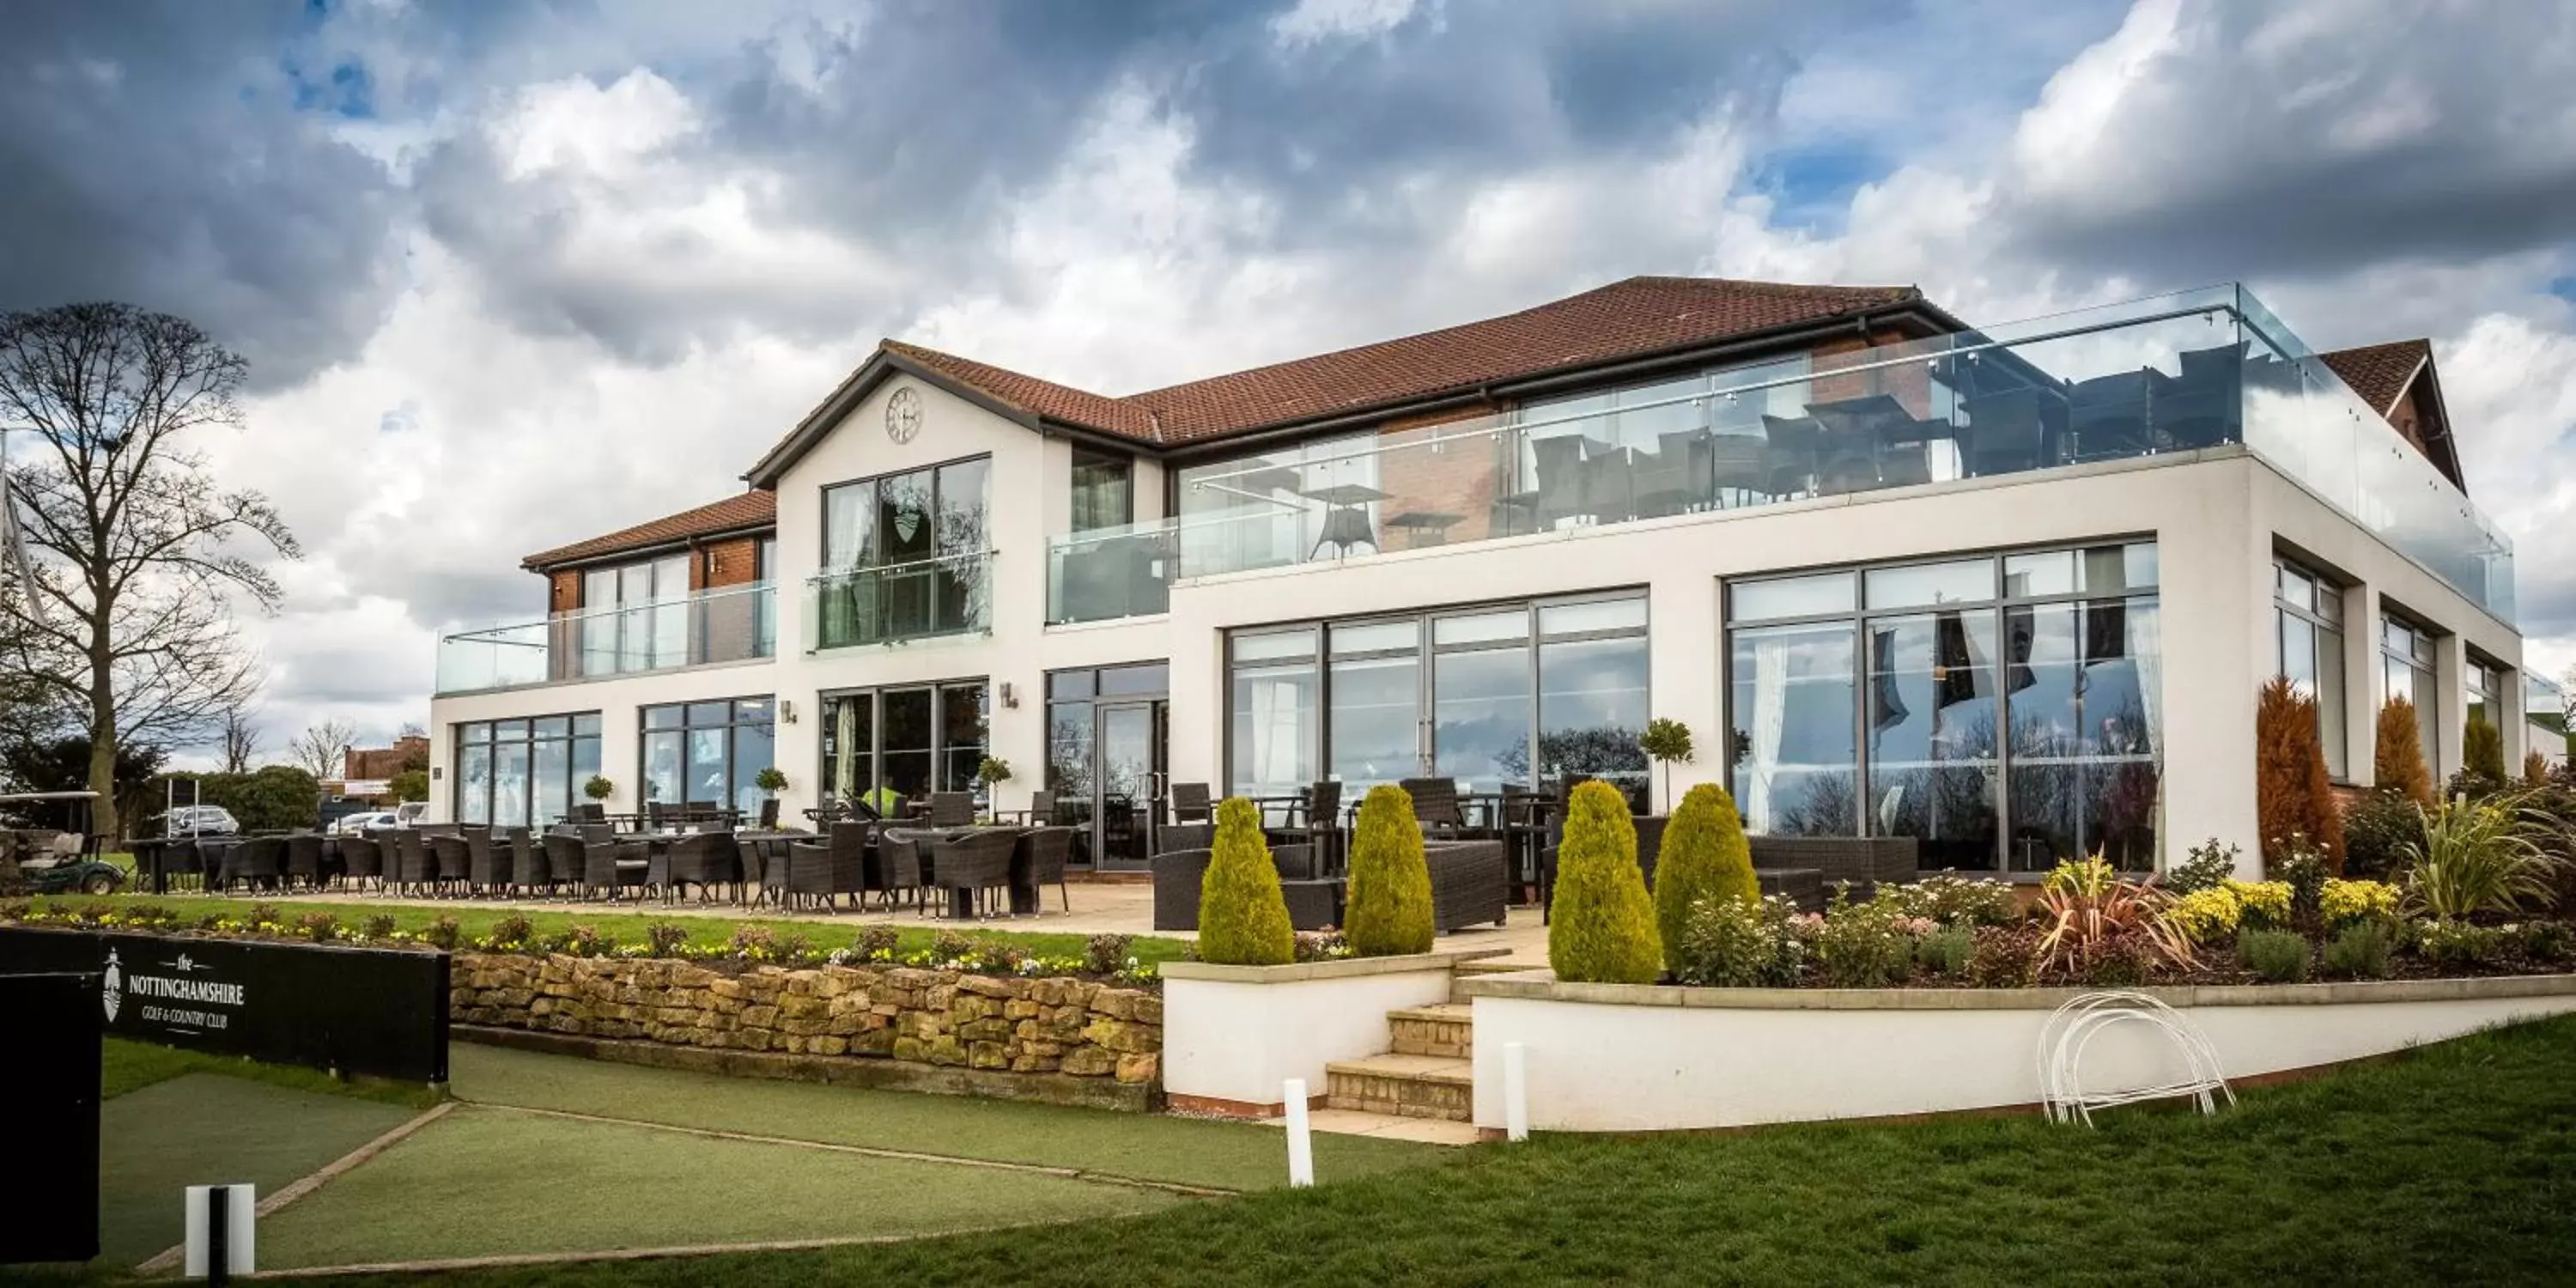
(438, 582), (778, 698)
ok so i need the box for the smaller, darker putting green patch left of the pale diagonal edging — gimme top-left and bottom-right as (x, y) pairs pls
(98, 1074), (417, 1267)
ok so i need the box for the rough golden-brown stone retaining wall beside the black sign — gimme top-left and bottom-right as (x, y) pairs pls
(448, 953), (1162, 1100)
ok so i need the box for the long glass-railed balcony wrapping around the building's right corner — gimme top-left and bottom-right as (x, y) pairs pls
(1149, 286), (2514, 623)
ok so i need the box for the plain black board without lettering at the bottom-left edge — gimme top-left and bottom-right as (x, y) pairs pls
(0, 974), (100, 1262)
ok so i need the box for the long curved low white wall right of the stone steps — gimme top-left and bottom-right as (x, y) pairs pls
(1463, 971), (2576, 1131)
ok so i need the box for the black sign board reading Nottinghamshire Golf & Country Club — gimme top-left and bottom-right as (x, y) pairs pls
(0, 927), (448, 1082)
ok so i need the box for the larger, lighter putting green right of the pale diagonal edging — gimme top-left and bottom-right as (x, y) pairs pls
(260, 1105), (1182, 1270)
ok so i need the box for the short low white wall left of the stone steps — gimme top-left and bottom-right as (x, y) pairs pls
(1162, 951), (1492, 1113)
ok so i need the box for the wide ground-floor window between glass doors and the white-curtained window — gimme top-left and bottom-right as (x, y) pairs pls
(1226, 595), (1646, 809)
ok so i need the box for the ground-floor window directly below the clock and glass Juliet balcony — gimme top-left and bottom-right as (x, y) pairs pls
(822, 680), (987, 811)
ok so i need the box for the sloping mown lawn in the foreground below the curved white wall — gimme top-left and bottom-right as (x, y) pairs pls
(276, 1020), (2576, 1288)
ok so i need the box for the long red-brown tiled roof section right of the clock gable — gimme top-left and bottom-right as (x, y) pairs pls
(884, 278), (1922, 446)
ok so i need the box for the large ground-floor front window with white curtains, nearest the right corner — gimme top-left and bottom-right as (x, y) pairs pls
(1726, 544), (2164, 871)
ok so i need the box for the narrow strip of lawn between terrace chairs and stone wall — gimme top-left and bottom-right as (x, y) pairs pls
(36, 894), (1190, 963)
